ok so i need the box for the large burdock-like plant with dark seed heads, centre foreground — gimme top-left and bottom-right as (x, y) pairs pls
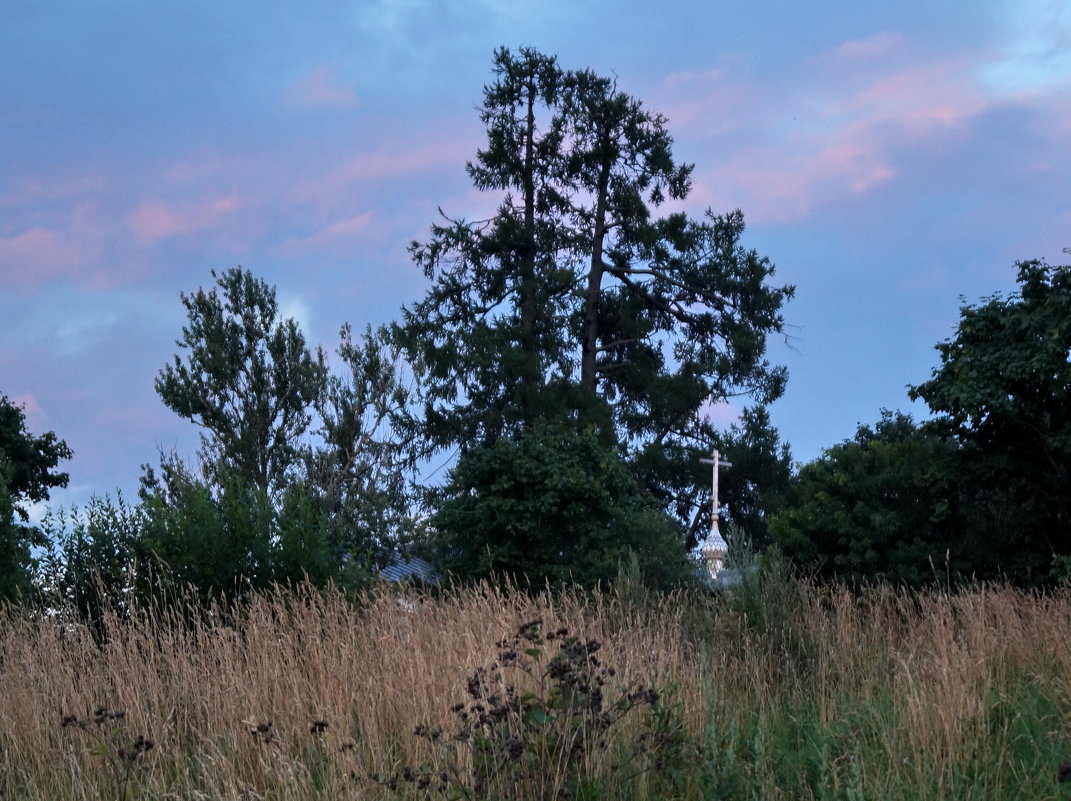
(369, 620), (699, 801)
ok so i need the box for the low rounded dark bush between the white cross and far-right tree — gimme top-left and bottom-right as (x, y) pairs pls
(770, 411), (963, 585)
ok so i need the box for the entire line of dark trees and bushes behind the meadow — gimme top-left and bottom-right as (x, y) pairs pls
(0, 48), (1071, 608)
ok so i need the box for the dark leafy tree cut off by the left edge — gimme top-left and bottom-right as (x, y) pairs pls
(0, 395), (72, 601)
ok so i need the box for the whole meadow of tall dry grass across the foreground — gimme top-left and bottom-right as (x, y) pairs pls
(0, 570), (1071, 801)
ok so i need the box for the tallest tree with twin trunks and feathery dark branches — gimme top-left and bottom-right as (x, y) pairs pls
(395, 48), (793, 552)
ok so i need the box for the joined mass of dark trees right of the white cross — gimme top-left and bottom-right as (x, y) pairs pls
(770, 253), (1071, 586)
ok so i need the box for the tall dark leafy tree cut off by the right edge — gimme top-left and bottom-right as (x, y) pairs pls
(910, 261), (1071, 583)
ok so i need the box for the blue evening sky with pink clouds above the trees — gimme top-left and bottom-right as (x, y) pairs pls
(0, 0), (1071, 514)
